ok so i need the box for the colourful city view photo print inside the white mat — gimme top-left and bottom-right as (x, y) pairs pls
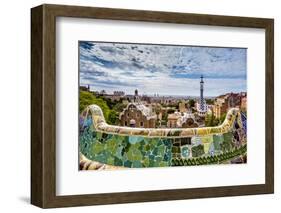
(79, 41), (247, 170)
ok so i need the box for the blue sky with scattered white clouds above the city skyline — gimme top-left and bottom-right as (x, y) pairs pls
(79, 41), (247, 96)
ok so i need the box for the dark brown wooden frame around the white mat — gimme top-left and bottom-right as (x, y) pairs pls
(31, 5), (274, 208)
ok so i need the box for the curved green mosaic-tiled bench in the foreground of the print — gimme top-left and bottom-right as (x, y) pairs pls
(79, 105), (247, 170)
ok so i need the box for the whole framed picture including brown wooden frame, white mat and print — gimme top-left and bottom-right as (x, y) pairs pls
(31, 5), (274, 208)
